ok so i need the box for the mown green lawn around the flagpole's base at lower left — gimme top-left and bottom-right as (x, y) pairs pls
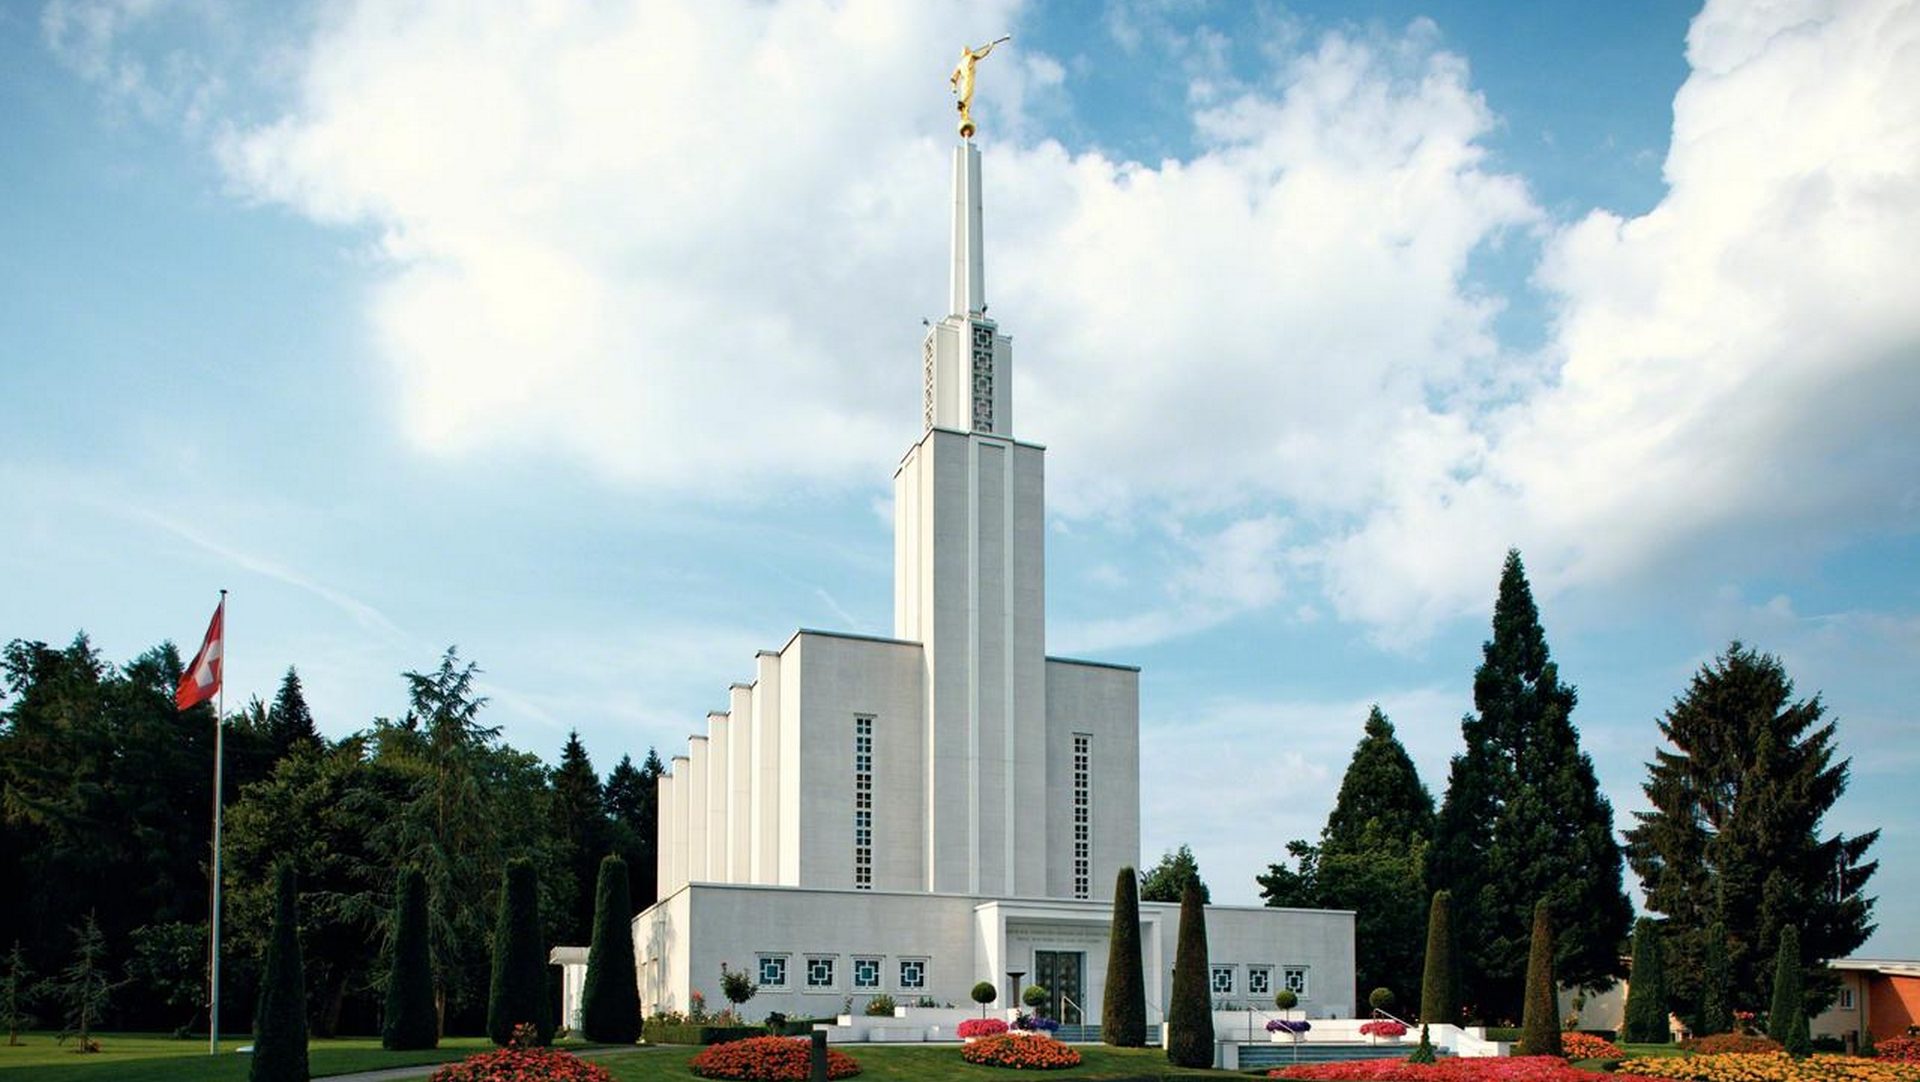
(0, 1032), (510, 1082)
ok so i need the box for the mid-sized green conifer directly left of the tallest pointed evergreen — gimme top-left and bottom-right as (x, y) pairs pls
(1256, 706), (1434, 992)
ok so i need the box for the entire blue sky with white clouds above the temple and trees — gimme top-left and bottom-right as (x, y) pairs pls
(0, 0), (1920, 957)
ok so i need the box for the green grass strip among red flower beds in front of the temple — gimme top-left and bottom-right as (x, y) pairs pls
(593, 1044), (1248, 1082)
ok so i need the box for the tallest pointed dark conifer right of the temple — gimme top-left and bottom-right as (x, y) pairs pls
(1427, 551), (1632, 1019)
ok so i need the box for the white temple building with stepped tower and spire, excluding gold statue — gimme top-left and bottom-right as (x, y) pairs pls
(634, 142), (1356, 1024)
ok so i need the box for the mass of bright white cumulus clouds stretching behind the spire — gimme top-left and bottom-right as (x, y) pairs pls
(180, 0), (1920, 647)
